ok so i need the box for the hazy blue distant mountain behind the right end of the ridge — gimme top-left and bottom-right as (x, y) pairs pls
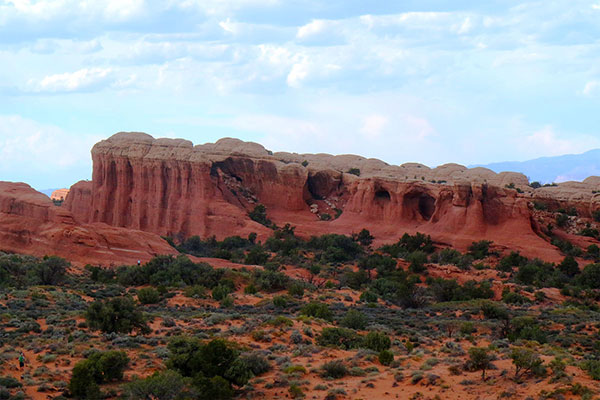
(469, 149), (600, 183)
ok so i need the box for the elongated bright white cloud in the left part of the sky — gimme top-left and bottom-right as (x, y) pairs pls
(29, 68), (114, 93)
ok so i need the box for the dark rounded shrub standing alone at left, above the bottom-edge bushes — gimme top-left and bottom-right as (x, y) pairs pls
(85, 297), (150, 333)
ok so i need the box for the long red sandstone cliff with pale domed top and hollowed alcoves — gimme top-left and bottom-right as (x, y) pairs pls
(64, 132), (597, 259)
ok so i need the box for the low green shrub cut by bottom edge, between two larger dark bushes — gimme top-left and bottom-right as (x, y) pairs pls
(123, 370), (186, 400)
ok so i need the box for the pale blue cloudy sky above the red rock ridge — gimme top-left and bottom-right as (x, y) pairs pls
(0, 0), (600, 189)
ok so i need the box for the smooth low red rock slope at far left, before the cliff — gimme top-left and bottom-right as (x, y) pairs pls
(0, 182), (174, 265)
